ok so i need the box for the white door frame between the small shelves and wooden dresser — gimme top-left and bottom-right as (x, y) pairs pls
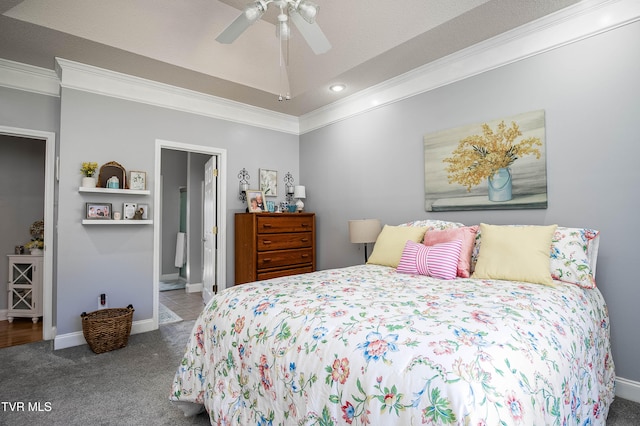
(153, 139), (227, 330)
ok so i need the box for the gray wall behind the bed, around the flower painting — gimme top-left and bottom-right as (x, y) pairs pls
(300, 23), (640, 381)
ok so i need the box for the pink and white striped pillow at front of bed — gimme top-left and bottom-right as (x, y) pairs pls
(396, 240), (462, 280)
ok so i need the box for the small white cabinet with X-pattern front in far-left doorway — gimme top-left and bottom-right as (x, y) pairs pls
(7, 255), (42, 323)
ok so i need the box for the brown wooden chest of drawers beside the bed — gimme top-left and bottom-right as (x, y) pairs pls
(235, 213), (316, 284)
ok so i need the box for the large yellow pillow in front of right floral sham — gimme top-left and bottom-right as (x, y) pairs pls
(472, 223), (557, 286)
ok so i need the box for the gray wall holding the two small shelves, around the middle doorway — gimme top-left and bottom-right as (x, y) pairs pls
(55, 88), (299, 334)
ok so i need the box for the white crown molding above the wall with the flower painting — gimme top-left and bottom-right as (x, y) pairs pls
(300, 0), (640, 134)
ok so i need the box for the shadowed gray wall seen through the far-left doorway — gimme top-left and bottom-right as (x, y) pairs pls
(0, 135), (46, 310)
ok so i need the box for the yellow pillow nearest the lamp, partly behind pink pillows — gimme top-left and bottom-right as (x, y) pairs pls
(367, 225), (427, 268)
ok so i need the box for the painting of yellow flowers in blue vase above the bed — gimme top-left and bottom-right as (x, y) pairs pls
(424, 110), (547, 211)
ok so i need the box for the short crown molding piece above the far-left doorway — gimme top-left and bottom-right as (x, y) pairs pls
(0, 58), (60, 97)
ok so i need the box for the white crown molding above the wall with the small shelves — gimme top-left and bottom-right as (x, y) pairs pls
(56, 58), (299, 134)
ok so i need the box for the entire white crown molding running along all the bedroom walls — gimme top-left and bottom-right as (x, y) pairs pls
(0, 0), (640, 135)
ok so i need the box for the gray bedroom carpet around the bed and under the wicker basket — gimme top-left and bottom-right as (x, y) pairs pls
(0, 321), (640, 426)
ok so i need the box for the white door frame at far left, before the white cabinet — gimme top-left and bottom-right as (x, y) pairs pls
(0, 126), (58, 340)
